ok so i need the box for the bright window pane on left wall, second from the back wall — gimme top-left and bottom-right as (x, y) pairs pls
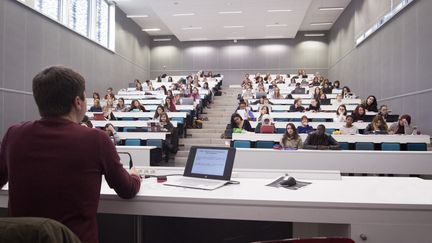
(69, 0), (90, 36)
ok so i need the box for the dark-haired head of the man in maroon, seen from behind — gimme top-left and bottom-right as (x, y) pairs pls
(33, 66), (85, 117)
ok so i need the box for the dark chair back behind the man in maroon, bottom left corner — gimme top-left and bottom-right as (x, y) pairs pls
(0, 217), (81, 243)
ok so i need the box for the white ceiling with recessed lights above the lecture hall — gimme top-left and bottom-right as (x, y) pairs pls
(115, 0), (350, 41)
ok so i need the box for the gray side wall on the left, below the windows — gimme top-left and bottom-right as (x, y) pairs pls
(0, 0), (150, 138)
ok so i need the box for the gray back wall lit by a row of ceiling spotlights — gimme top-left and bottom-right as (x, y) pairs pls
(150, 33), (328, 85)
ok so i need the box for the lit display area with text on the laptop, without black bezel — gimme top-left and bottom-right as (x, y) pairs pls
(192, 148), (228, 176)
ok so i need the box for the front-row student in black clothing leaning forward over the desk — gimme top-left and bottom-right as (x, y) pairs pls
(303, 124), (340, 149)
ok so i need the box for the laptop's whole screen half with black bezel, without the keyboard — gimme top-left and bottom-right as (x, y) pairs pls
(184, 146), (235, 180)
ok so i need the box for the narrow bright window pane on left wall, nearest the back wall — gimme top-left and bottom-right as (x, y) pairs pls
(96, 0), (109, 46)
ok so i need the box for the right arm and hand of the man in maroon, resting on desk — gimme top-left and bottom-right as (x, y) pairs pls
(99, 133), (141, 199)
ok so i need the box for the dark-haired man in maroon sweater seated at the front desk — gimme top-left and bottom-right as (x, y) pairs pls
(0, 67), (141, 243)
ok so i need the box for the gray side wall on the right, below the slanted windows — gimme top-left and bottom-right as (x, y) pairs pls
(328, 0), (432, 134)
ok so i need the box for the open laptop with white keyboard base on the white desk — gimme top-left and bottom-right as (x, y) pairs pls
(164, 146), (236, 190)
